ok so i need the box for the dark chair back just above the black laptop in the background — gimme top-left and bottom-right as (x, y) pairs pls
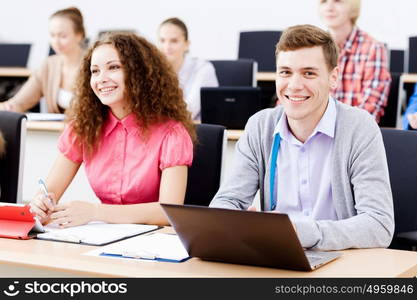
(211, 59), (258, 86)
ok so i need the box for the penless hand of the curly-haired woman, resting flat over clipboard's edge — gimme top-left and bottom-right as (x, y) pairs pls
(51, 201), (98, 228)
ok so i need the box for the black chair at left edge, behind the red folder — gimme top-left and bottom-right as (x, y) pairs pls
(0, 111), (26, 203)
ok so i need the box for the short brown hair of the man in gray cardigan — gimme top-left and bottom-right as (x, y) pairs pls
(275, 25), (339, 71)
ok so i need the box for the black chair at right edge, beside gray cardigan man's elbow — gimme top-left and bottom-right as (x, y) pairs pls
(381, 129), (417, 250)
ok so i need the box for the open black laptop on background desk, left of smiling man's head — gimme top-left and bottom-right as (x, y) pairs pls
(201, 87), (262, 129)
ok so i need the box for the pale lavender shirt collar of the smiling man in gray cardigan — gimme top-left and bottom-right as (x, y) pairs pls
(274, 97), (337, 141)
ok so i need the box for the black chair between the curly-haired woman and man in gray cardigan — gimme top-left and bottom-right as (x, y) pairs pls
(184, 124), (227, 206)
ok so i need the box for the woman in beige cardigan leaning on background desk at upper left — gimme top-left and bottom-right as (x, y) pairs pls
(0, 7), (85, 113)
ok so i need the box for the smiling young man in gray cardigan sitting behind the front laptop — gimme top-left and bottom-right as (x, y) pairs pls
(210, 25), (394, 250)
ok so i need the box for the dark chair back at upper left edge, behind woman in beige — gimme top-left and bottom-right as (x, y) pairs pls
(0, 43), (32, 68)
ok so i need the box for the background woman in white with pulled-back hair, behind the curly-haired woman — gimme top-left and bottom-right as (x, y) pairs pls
(158, 18), (219, 121)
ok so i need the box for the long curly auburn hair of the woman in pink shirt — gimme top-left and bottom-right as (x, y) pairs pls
(69, 33), (196, 152)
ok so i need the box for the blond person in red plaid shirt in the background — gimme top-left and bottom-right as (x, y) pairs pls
(319, 0), (391, 122)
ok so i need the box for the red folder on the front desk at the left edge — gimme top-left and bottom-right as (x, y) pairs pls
(0, 204), (35, 240)
